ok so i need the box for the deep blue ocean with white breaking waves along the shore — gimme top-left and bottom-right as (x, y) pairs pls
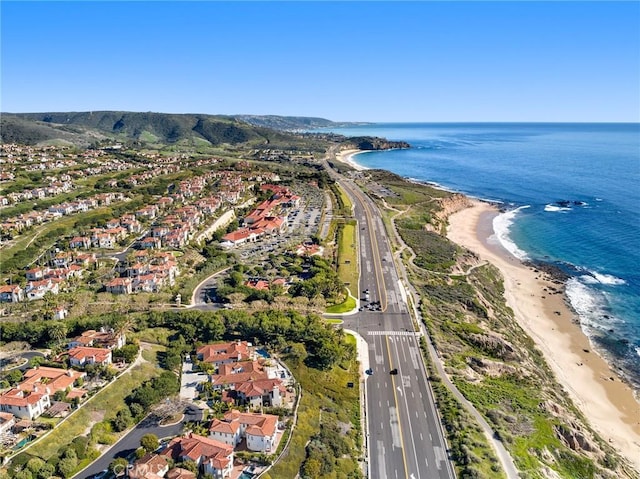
(322, 123), (640, 391)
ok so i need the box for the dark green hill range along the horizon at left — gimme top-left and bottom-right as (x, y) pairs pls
(0, 111), (360, 146)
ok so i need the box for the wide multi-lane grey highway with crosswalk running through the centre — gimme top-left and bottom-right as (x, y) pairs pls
(339, 179), (455, 479)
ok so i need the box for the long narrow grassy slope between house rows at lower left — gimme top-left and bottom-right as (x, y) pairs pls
(24, 346), (164, 460)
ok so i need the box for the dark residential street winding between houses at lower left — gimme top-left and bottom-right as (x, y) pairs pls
(73, 406), (197, 479)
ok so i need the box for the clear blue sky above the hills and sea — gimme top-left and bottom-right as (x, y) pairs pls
(0, 0), (640, 122)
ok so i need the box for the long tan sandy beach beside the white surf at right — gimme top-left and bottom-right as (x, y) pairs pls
(448, 201), (640, 470)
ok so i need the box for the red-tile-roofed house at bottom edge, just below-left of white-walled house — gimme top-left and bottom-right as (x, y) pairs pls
(161, 433), (233, 479)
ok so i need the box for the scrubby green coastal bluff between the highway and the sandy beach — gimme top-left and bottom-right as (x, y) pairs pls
(362, 171), (632, 479)
